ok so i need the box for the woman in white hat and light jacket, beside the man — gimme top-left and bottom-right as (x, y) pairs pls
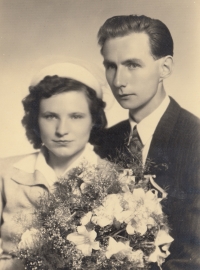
(0, 63), (106, 270)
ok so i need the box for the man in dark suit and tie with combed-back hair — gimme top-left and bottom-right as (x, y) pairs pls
(97, 15), (200, 270)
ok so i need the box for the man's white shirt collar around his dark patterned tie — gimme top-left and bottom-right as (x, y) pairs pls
(129, 95), (170, 145)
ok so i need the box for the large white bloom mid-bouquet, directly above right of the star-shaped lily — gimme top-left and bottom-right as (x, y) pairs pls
(91, 194), (123, 227)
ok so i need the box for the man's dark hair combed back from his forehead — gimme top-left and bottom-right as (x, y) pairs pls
(98, 15), (173, 59)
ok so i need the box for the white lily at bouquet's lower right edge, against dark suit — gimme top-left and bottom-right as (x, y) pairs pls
(149, 230), (174, 267)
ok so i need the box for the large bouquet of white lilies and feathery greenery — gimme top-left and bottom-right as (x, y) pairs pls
(16, 157), (173, 270)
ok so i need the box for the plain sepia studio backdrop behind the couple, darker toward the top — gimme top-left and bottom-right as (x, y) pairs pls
(0, 0), (200, 157)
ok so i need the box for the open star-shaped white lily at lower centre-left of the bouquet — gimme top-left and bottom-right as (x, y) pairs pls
(67, 226), (100, 256)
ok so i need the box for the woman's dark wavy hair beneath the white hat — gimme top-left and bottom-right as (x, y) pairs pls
(22, 75), (107, 149)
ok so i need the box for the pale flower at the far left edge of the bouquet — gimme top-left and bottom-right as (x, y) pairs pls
(18, 228), (40, 249)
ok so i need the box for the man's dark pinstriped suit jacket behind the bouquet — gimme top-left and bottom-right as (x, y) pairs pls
(97, 98), (200, 270)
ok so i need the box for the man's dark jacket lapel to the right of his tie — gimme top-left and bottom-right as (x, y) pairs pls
(148, 98), (181, 167)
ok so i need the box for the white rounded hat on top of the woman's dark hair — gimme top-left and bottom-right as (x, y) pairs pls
(31, 62), (103, 98)
